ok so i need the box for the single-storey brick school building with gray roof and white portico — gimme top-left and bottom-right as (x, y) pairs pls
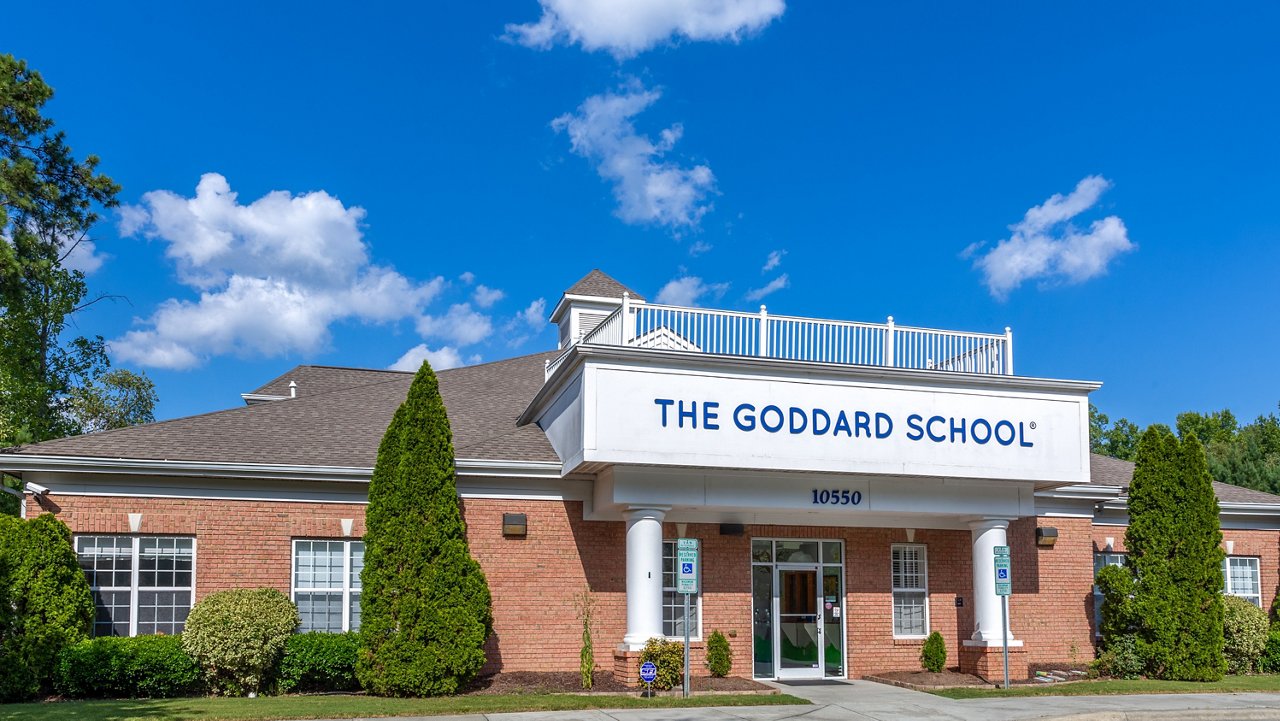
(0, 271), (1280, 681)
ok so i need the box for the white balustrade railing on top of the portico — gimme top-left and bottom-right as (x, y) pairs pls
(547, 296), (1014, 378)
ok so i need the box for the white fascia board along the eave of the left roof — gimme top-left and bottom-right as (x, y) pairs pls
(0, 455), (561, 483)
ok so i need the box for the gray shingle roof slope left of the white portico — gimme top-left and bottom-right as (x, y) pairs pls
(8, 351), (558, 467)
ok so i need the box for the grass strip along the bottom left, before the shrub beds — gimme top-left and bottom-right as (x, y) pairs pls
(0, 694), (809, 721)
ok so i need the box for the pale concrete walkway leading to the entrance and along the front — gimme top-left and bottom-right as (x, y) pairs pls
(314, 681), (1280, 721)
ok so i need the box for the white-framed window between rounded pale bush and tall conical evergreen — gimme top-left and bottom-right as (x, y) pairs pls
(293, 540), (365, 633)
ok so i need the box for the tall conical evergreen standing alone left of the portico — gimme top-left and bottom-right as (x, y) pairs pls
(356, 362), (493, 695)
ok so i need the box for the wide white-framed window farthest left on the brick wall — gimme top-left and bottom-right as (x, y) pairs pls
(76, 535), (196, 636)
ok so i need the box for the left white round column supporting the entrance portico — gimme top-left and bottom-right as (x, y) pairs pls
(622, 508), (667, 651)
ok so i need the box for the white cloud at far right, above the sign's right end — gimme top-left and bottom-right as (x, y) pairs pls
(961, 175), (1137, 300)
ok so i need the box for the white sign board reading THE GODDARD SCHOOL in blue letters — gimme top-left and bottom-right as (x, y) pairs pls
(584, 368), (1088, 483)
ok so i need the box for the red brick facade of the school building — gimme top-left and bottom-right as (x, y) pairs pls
(29, 494), (1280, 677)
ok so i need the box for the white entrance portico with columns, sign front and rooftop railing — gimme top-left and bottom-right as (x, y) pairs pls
(520, 288), (1098, 677)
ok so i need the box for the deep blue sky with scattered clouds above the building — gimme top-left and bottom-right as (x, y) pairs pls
(0, 0), (1280, 423)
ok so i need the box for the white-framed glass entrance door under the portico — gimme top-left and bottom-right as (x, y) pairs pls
(774, 565), (823, 679)
